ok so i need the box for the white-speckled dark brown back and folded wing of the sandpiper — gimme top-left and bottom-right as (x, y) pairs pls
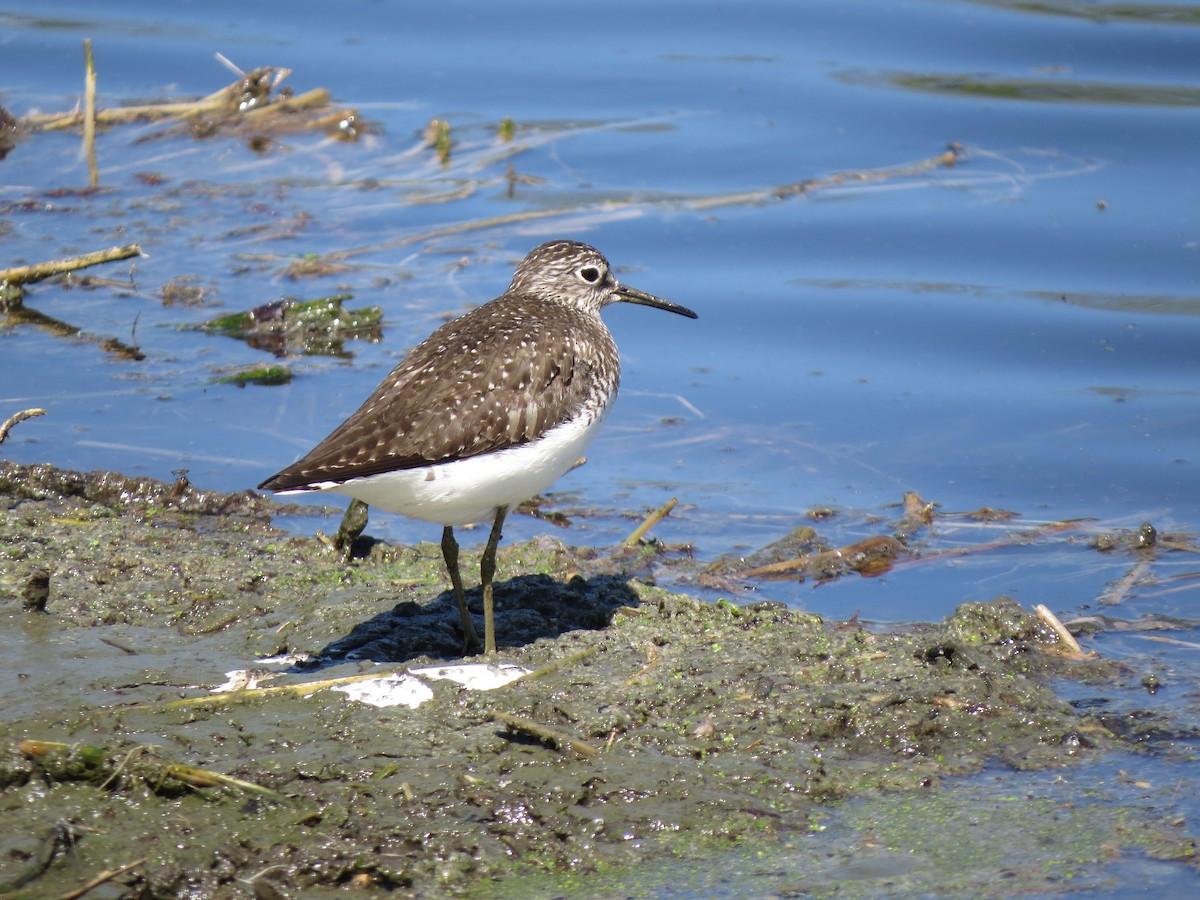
(259, 296), (619, 491)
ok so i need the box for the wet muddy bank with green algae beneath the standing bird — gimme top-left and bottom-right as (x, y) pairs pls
(0, 463), (1194, 898)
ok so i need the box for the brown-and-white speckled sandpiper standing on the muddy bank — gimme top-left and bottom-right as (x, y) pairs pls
(259, 241), (696, 655)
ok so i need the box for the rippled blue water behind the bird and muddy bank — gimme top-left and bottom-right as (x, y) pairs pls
(0, 0), (1200, 897)
